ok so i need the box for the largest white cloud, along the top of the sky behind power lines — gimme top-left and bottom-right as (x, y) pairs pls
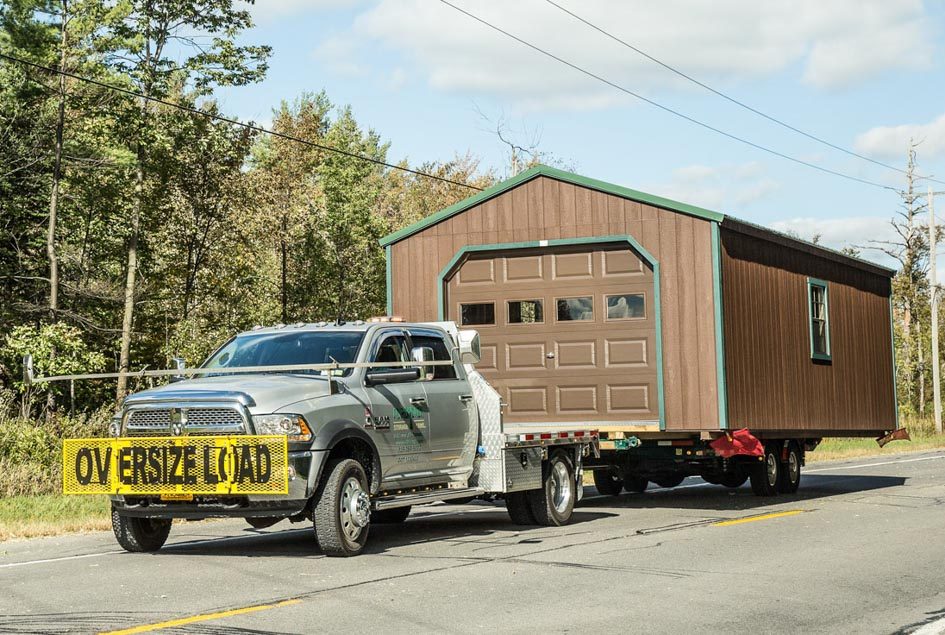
(318, 0), (933, 109)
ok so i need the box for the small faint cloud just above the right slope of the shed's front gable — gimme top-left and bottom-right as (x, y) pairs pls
(649, 162), (779, 213)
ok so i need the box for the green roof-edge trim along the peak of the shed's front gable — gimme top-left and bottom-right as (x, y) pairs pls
(380, 165), (725, 247)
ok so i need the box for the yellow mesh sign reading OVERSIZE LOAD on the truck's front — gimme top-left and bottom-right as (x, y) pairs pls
(62, 435), (289, 495)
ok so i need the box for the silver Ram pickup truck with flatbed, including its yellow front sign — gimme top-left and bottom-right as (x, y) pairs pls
(53, 321), (597, 556)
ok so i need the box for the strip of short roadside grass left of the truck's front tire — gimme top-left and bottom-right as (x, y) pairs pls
(0, 494), (111, 542)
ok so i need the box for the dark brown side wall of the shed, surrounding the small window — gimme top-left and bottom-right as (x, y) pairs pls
(721, 227), (896, 432)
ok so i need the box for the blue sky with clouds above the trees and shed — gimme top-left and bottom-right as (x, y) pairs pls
(218, 0), (945, 261)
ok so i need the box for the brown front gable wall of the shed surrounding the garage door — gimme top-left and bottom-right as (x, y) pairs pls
(391, 176), (719, 430)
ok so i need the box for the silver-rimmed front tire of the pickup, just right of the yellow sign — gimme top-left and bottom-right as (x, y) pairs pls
(312, 459), (371, 557)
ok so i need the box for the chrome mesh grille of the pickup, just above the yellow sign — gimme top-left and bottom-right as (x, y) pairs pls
(125, 405), (246, 436)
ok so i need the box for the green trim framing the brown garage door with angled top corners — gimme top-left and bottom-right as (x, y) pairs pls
(436, 234), (666, 430)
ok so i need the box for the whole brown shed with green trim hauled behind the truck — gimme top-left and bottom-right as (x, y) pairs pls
(381, 166), (896, 436)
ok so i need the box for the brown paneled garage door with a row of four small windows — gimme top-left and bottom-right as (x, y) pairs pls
(445, 244), (659, 423)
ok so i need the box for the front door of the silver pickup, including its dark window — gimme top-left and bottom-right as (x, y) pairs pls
(365, 329), (433, 489)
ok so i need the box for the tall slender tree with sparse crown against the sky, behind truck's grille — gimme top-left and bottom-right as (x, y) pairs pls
(111, 0), (270, 398)
